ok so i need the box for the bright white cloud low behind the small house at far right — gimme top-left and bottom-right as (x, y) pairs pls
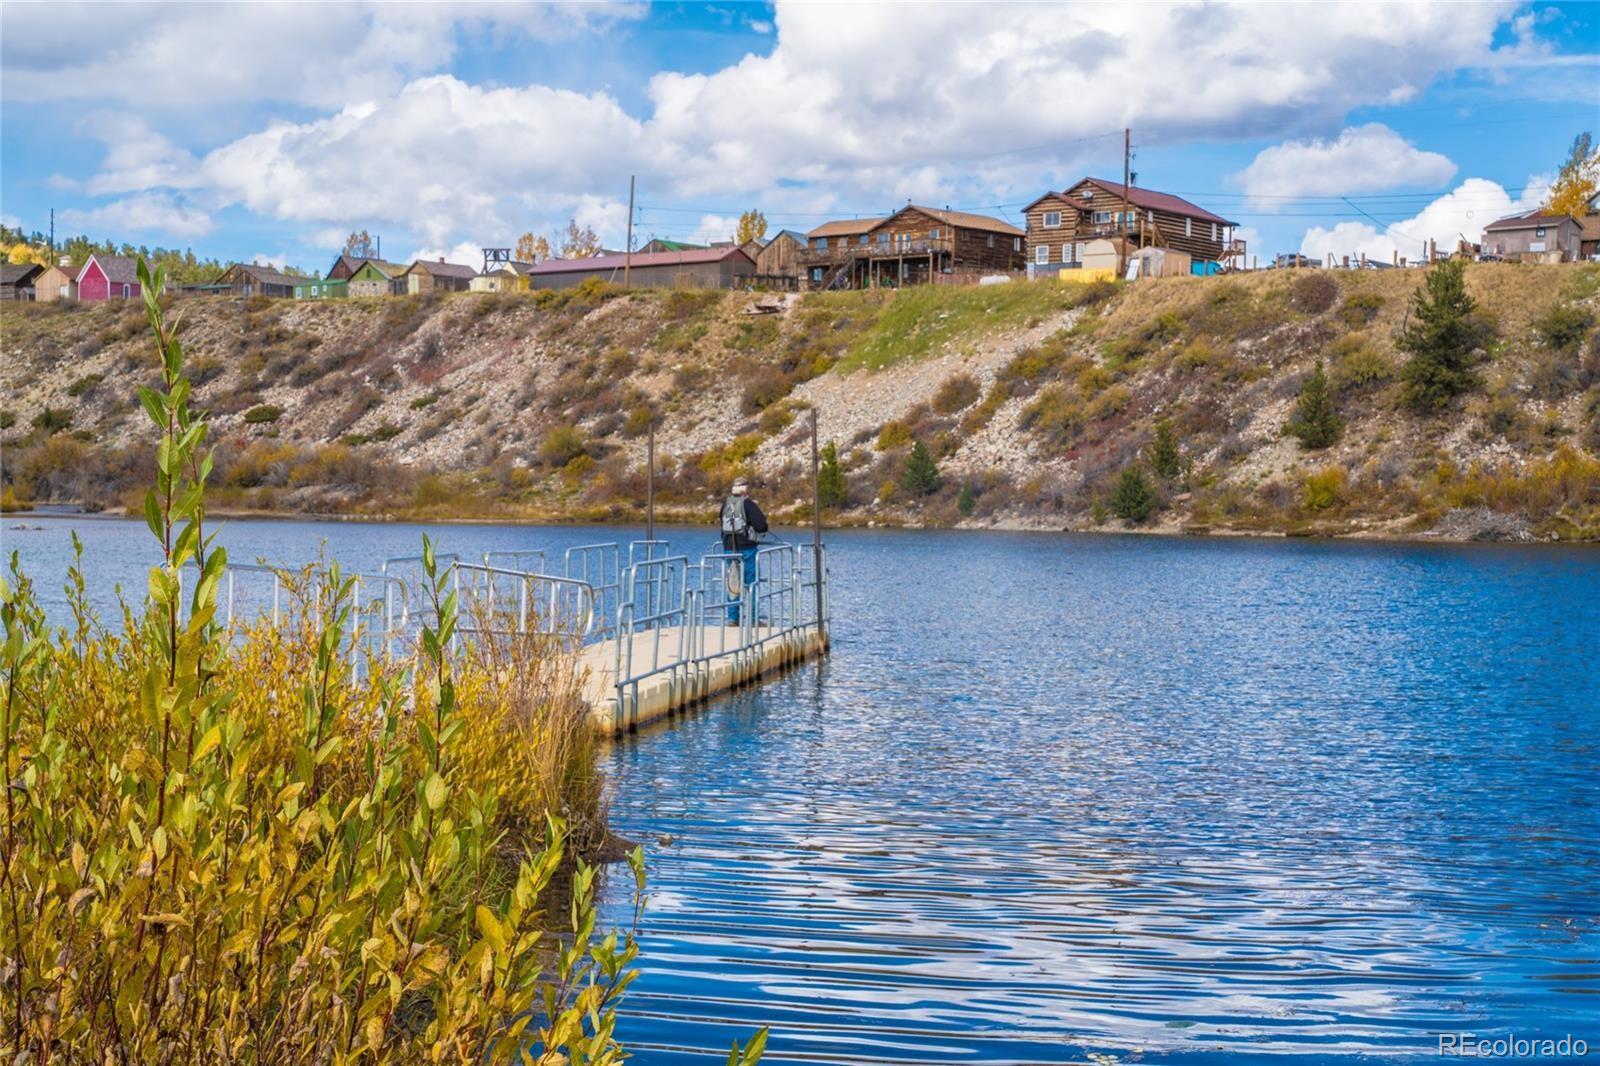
(1301, 178), (1544, 262)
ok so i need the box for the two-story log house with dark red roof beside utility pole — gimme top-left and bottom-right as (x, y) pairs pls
(1022, 178), (1245, 277)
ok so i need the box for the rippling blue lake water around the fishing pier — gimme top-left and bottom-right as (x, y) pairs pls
(5, 519), (1600, 1063)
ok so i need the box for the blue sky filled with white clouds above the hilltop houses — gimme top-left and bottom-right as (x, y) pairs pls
(0, 0), (1600, 271)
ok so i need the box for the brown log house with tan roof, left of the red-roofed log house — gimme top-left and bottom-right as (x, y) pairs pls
(797, 205), (1026, 288)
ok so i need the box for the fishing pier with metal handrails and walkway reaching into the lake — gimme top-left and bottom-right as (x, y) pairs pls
(190, 539), (830, 733)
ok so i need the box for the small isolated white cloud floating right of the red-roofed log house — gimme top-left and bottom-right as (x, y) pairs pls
(1235, 122), (1456, 206)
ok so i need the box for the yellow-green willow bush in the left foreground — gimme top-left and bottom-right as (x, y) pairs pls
(0, 261), (765, 1063)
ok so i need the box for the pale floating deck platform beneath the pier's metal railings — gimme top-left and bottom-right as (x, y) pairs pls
(582, 624), (827, 736)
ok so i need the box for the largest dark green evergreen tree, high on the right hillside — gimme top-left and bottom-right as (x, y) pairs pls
(1395, 259), (1483, 413)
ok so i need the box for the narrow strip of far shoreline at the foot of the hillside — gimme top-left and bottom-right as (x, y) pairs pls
(0, 503), (1600, 547)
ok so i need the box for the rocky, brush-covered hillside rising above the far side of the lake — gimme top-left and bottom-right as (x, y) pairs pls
(0, 264), (1600, 539)
